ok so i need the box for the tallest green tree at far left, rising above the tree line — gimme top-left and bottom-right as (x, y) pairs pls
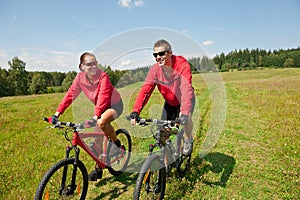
(8, 57), (29, 95)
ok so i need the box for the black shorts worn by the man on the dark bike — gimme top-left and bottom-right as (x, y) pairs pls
(161, 96), (196, 120)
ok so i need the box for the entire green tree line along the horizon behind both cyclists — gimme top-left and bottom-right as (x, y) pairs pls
(0, 47), (300, 97)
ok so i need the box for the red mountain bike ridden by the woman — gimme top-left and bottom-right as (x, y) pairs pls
(35, 118), (131, 200)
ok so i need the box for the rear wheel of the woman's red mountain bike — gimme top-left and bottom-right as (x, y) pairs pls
(106, 129), (132, 176)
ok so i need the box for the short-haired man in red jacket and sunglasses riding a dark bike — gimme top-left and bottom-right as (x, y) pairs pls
(130, 40), (195, 155)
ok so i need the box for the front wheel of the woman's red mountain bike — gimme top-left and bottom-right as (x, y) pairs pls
(34, 158), (88, 200)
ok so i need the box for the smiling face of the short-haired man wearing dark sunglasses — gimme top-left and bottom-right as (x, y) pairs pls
(153, 46), (172, 67)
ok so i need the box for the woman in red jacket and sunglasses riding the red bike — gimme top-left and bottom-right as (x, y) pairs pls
(53, 52), (123, 180)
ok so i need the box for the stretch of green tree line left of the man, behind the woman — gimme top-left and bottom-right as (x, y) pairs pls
(0, 57), (149, 97)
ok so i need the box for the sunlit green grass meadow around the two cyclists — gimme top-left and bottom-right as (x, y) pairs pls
(0, 69), (300, 200)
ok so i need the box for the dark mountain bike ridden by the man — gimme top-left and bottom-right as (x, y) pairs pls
(134, 119), (191, 199)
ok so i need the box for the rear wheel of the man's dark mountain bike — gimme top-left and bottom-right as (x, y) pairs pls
(176, 129), (191, 177)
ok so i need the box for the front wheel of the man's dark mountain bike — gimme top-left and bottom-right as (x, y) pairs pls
(133, 154), (166, 200)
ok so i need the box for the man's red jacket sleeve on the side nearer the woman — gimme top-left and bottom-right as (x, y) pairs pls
(132, 66), (156, 114)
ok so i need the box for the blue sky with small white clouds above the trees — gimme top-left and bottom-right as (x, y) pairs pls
(0, 0), (300, 72)
